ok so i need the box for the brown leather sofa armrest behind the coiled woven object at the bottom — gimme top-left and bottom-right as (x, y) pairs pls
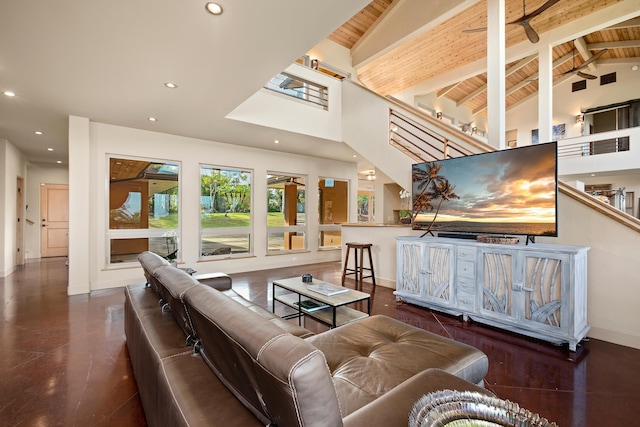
(343, 369), (493, 427)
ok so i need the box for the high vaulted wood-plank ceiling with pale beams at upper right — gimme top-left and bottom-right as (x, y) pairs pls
(329, 0), (640, 113)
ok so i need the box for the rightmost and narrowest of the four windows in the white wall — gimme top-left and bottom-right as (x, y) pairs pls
(318, 178), (349, 248)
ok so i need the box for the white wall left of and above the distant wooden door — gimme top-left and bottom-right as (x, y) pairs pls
(24, 163), (69, 259)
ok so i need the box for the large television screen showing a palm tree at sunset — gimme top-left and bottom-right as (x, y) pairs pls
(412, 142), (558, 236)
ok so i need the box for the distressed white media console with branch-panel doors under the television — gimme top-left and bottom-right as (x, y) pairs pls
(395, 237), (589, 351)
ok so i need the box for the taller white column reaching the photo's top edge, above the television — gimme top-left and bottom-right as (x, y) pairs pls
(487, 0), (506, 150)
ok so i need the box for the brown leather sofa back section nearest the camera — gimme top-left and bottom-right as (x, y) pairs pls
(184, 286), (342, 427)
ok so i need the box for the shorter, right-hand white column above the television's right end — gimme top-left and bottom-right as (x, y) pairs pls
(538, 44), (553, 143)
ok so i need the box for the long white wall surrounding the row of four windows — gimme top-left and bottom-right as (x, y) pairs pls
(68, 118), (357, 294)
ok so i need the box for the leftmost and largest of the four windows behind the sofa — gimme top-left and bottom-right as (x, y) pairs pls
(107, 157), (179, 264)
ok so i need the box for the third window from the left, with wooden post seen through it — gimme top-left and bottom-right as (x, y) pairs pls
(267, 173), (307, 254)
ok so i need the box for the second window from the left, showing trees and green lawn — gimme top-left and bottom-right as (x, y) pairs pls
(200, 165), (253, 258)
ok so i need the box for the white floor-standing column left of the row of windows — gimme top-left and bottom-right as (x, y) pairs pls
(67, 116), (95, 295)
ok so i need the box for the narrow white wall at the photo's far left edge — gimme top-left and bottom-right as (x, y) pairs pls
(0, 139), (27, 277)
